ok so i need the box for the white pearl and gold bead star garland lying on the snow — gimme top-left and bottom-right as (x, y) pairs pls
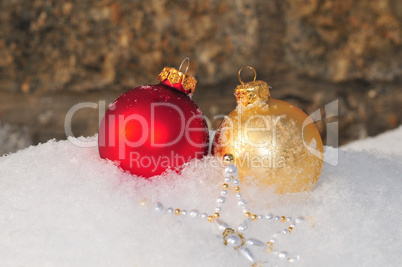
(140, 155), (305, 266)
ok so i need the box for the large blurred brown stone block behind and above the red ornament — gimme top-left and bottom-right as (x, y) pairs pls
(0, 0), (258, 92)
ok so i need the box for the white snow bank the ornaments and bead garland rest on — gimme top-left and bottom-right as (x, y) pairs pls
(0, 127), (402, 266)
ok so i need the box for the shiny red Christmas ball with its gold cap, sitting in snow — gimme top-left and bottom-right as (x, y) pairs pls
(98, 58), (209, 178)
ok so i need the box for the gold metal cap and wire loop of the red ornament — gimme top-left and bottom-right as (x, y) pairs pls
(158, 57), (197, 94)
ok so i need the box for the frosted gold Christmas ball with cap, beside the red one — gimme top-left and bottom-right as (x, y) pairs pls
(212, 66), (324, 193)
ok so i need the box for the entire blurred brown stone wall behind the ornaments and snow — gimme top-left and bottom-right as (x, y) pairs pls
(0, 0), (402, 155)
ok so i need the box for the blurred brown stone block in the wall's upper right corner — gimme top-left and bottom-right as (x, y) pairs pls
(285, 0), (402, 82)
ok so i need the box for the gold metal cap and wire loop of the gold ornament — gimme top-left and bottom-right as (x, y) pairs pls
(235, 65), (271, 106)
